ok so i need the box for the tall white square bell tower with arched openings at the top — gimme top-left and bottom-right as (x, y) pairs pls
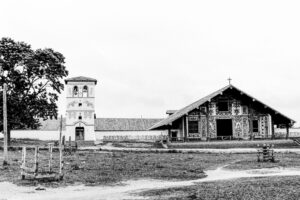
(65, 76), (97, 141)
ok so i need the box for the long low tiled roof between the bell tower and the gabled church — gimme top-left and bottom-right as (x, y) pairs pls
(95, 118), (163, 131)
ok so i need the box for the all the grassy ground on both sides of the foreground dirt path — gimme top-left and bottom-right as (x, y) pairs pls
(0, 140), (300, 200)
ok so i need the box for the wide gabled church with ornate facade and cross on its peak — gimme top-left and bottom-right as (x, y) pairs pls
(150, 83), (295, 141)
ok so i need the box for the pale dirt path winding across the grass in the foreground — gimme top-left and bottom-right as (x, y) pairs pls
(0, 167), (300, 200)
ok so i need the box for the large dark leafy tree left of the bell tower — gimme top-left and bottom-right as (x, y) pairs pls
(0, 38), (68, 144)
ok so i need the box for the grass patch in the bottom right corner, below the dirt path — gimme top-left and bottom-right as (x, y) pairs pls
(142, 177), (300, 200)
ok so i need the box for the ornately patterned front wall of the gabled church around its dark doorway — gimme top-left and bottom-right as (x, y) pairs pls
(181, 95), (269, 139)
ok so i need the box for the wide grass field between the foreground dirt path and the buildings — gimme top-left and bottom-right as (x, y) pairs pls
(0, 150), (300, 186)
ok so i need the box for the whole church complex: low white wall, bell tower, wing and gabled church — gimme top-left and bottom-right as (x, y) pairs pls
(7, 76), (295, 143)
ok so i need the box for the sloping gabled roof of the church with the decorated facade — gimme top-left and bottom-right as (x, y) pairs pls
(150, 84), (295, 130)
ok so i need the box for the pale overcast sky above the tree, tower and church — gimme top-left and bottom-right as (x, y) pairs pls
(0, 0), (300, 124)
